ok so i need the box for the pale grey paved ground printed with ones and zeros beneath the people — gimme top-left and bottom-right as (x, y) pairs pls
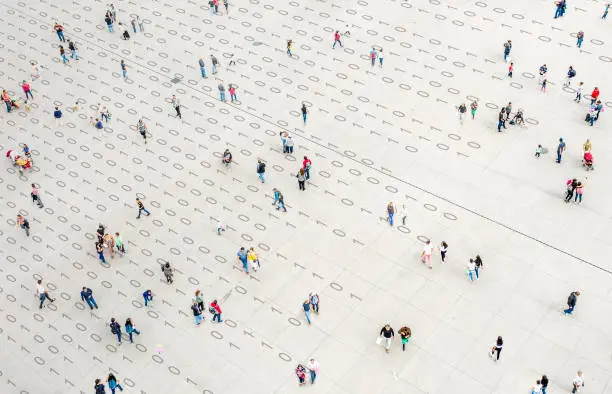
(0, 0), (612, 394)
